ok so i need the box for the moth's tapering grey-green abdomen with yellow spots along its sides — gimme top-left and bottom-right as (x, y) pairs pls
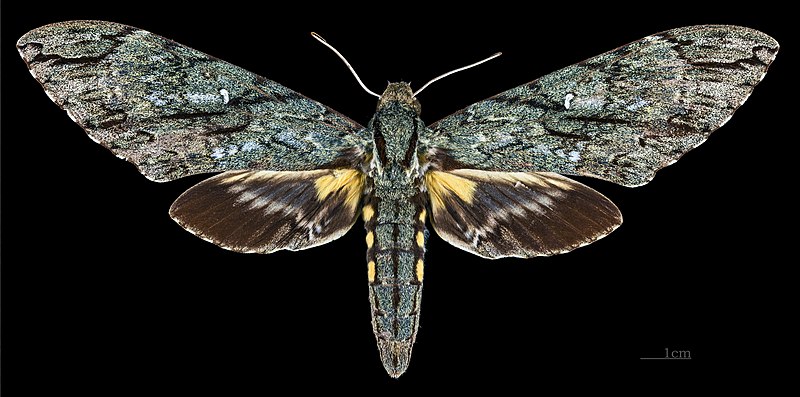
(363, 196), (426, 377)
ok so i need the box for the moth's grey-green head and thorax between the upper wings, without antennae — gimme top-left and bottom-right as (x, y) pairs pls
(368, 83), (425, 176)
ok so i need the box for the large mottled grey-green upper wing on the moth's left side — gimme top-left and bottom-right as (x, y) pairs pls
(17, 21), (369, 181)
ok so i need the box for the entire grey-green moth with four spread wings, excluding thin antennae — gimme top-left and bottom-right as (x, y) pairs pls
(17, 21), (778, 377)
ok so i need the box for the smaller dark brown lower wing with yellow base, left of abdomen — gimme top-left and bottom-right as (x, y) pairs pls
(170, 169), (364, 253)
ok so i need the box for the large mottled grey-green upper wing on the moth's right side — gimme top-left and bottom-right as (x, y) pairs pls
(420, 26), (778, 186)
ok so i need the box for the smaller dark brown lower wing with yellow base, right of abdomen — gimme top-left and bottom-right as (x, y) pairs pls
(425, 169), (622, 259)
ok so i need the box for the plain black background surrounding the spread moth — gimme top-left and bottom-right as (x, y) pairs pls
(2, 1), (797, 395)
